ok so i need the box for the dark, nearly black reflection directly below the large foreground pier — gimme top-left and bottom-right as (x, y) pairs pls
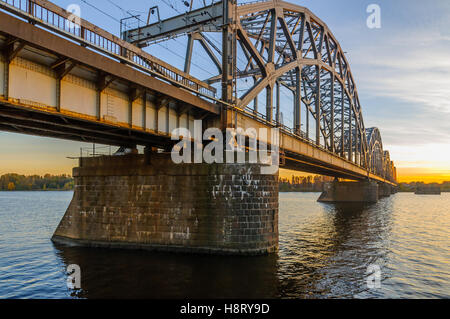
(52, 245), (277, 298)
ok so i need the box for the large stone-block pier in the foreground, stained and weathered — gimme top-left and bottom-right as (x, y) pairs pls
(52, 153), (278, 255)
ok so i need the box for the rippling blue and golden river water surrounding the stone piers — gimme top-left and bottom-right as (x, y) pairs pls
(0, 192), (450, 298)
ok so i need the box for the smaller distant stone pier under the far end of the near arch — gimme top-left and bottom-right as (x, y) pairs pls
(318, 181), (378, 203)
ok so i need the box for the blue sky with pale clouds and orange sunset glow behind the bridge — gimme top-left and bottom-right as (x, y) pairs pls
(0, 0), (450, 182)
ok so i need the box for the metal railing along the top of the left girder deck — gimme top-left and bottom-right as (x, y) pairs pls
(0, 0), (216, 99)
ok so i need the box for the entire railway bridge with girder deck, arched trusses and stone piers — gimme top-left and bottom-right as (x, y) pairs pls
(0, 0), (396, 252)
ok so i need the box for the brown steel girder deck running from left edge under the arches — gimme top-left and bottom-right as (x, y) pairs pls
(0, 2), (395, 185)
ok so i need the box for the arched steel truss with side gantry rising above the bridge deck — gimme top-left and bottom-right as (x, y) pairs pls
(123, 0), (395, 181)
